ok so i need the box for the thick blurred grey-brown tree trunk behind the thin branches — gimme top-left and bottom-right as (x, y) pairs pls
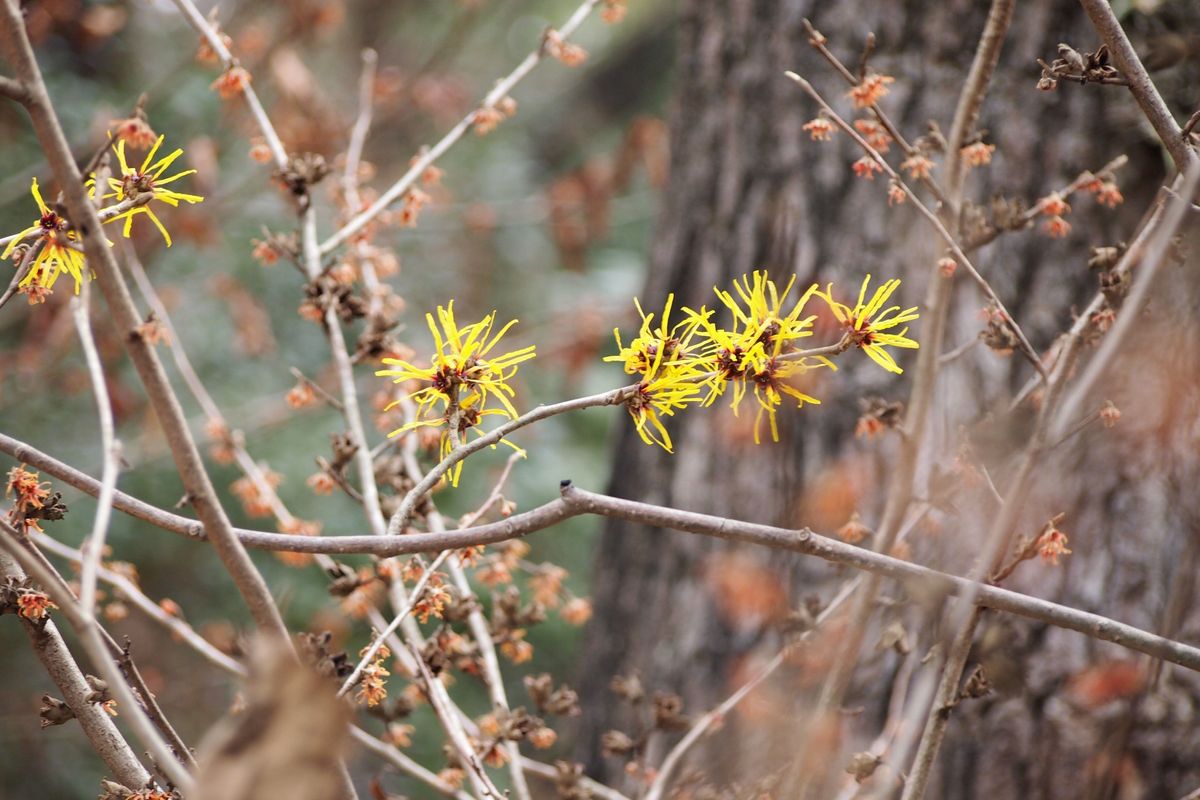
(578, 0), (1200, 799)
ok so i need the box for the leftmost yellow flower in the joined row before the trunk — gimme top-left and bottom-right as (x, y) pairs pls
(605, 294), (710, 452)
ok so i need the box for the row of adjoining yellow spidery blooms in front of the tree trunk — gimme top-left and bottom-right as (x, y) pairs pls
(605, 271), (918, 452)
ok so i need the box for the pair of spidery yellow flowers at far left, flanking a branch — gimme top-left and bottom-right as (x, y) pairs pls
(0, 137), (204, 303)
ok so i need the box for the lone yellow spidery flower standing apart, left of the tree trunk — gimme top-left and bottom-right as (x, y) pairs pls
(376, 301), (536, 486)
